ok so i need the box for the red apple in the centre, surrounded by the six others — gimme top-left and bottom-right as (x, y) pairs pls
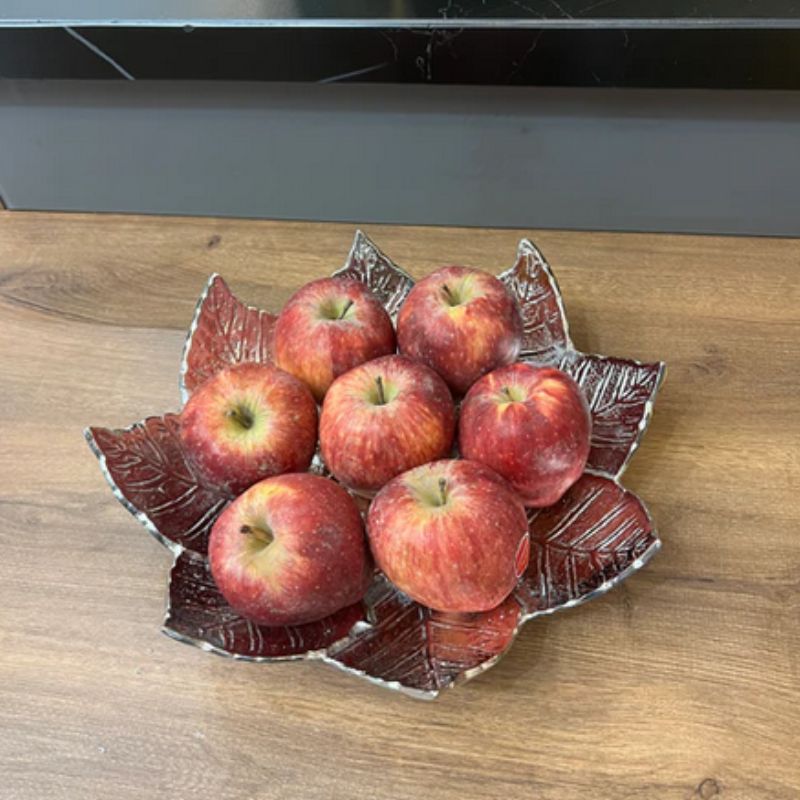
(319, 356), (455, 492)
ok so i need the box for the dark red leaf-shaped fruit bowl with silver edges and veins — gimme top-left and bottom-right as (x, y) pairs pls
(86, 231), (664, 698)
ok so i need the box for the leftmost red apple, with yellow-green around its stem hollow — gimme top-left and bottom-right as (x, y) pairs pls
(180, 364), (317, 494)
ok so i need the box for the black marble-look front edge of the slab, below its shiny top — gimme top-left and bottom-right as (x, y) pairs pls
(0, 28), (800, 89)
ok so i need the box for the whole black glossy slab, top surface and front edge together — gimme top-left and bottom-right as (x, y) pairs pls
(0, 0), (800, 89)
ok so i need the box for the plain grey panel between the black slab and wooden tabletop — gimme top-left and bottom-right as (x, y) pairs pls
(0, 81), (800, 235)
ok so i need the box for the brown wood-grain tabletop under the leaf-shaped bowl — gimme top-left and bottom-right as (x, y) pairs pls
(0, 212), (800, 800)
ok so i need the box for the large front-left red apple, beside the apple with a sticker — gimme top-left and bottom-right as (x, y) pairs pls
(208, 472), (372, 625)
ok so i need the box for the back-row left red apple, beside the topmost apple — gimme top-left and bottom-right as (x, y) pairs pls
(273, 278), (395, 402)
